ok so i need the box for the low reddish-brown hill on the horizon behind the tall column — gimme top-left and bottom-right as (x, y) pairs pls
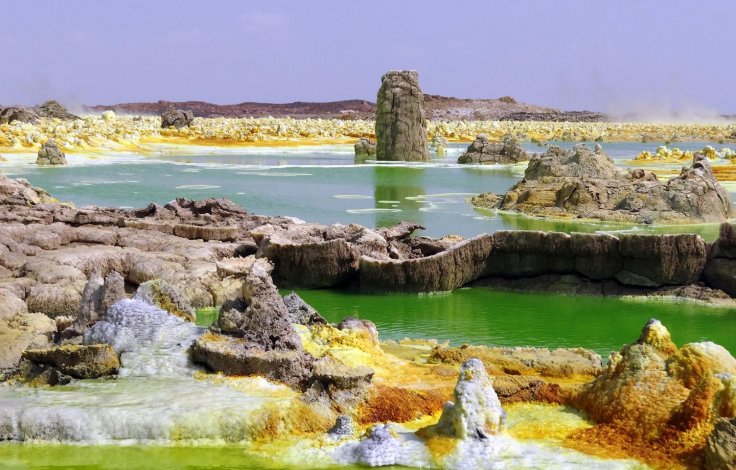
(86, 94), (608, 122)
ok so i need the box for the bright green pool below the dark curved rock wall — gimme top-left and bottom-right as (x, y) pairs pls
(298, 288), (736, 358)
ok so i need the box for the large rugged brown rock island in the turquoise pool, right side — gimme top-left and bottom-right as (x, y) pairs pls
(473, 144), (736, 224)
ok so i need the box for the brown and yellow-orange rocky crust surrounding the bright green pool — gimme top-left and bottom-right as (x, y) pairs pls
(0, 178), (736, 468)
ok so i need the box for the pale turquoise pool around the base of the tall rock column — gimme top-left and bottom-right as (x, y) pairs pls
(0, 142), (723, 239)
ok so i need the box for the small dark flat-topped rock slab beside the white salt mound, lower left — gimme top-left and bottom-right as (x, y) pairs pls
(23, 344), (120, 379)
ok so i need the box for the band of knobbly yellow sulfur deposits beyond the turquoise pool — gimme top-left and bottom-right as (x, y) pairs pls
(0, 115), (734, 158)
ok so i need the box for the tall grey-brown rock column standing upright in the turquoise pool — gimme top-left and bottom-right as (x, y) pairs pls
(376, 70), (430, 162)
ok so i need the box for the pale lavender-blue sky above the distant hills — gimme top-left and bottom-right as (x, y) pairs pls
(0, 0), (736, 115)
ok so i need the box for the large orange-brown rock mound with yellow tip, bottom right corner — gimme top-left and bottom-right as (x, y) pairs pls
(573, 320), (736, 466)
